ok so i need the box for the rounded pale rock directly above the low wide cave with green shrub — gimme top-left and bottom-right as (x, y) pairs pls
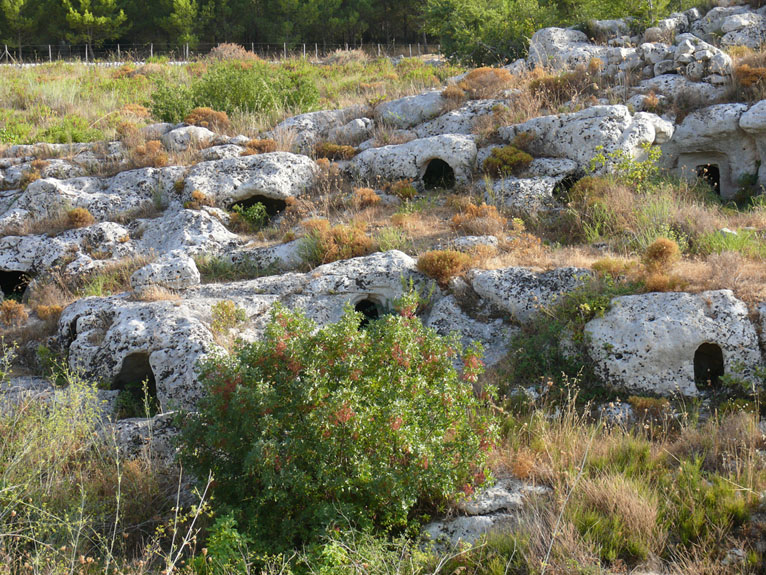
(184, 152), (316, 207)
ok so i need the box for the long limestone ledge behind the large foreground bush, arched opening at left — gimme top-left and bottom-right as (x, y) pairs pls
(59, 251), (439, 411)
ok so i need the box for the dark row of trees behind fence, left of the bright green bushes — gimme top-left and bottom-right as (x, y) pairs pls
(0, 0), (426, 58)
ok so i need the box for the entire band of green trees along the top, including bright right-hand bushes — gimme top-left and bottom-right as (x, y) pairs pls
(0, 0), (704, 62)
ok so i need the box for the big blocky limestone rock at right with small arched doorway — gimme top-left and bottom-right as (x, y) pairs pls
(585, 290), (762, 395)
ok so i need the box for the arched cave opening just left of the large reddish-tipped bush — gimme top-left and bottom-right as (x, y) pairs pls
(112, 352), (160, 419)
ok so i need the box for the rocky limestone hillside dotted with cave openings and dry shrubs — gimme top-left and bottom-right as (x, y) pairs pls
(6, 3), (766, 572)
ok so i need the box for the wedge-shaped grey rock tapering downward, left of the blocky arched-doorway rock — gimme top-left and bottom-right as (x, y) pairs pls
(468, 267), (591, 323)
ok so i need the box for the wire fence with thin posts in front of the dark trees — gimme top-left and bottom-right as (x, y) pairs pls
(0, 42), (441, 65)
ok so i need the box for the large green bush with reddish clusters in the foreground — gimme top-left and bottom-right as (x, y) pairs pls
(182, 295), (494, 552)
